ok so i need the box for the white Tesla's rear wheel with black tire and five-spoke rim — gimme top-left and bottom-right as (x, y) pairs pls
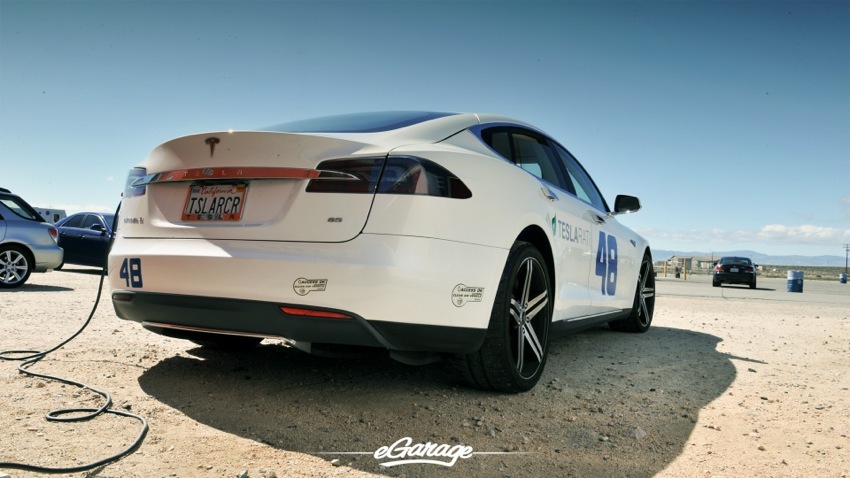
(457, 242), (553, 393)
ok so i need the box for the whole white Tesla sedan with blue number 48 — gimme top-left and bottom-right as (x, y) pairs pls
(108, 111), (655, 392)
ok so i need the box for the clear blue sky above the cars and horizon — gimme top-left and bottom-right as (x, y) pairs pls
(0, 0), (850, 256)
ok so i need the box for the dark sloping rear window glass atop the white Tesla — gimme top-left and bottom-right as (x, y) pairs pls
(262, 111), (457, 133)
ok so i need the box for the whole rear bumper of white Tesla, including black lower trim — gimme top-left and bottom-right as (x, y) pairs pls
(108, 234), (508, 352)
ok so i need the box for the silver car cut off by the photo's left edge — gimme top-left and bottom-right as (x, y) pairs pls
(0, 188), (63, 289)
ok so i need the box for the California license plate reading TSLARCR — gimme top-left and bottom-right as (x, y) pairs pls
(183, 184), (243, 221)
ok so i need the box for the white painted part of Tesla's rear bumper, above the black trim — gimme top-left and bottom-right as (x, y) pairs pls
(109, 234), (507, 328)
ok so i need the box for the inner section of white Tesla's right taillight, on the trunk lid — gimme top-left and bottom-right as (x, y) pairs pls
(307, 158), (384, 194)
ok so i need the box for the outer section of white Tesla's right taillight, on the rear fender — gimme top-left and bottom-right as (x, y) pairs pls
(378, 156), (472, 199)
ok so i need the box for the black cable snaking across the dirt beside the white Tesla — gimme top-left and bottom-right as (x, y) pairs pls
(0, 211), (148, 473)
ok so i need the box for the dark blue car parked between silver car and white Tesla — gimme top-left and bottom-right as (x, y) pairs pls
(56, 212), (115, 267)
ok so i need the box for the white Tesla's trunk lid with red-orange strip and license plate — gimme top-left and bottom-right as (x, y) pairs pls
(121, 132), (387, 242)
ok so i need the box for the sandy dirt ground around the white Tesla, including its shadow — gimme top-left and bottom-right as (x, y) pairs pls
(0, 266), (850, 478)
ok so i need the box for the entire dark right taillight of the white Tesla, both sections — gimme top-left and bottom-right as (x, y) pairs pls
(307, 156), (472, 199)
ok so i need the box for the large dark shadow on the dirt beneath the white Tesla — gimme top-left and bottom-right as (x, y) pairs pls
(139, 327), (736, 477)
